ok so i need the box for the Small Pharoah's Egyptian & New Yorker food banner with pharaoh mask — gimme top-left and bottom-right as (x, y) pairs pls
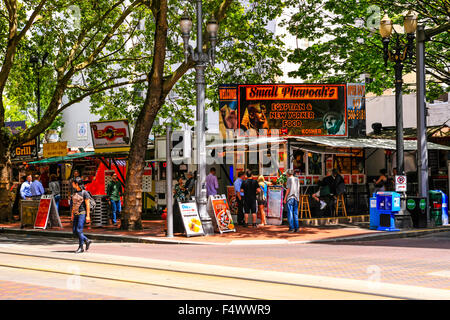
(219, 84), (348, 137)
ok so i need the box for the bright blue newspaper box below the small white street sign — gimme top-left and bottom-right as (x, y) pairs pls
(376, 191), (400, 231)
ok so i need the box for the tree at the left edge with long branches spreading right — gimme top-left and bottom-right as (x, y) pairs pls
(0, 0), (148, 220)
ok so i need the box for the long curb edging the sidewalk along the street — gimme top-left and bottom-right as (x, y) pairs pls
(0, 226), (450, 245)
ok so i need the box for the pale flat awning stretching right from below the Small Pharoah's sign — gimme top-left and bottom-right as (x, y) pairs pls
(289, 136), (450, 151)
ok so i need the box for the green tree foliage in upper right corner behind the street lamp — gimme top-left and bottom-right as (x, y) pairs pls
(285, 0), (450, 100)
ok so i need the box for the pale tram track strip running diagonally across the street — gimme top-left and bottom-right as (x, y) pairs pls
(0, 251), (404, 300)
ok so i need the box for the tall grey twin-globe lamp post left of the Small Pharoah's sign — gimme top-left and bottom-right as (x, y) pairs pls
(180, 0), (219, 235)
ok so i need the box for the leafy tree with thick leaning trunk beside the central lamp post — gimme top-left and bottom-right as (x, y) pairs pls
(85, 0), (284, 229)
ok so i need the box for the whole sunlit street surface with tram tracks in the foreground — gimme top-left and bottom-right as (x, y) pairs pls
(0, 232), (450, 300)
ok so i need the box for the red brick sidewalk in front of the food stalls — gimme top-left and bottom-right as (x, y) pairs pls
(0, 216), (450, 245)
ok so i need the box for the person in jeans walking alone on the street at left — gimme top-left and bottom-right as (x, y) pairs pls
(72, 177), (92, 253)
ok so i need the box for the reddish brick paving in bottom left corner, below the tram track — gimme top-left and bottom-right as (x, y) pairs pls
(0, 280), (120, 300)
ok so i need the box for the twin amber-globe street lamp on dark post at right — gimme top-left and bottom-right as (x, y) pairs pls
(380, 11), (417, 175)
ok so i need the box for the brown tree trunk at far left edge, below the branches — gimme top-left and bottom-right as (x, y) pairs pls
(0, 137), (14, 222)
